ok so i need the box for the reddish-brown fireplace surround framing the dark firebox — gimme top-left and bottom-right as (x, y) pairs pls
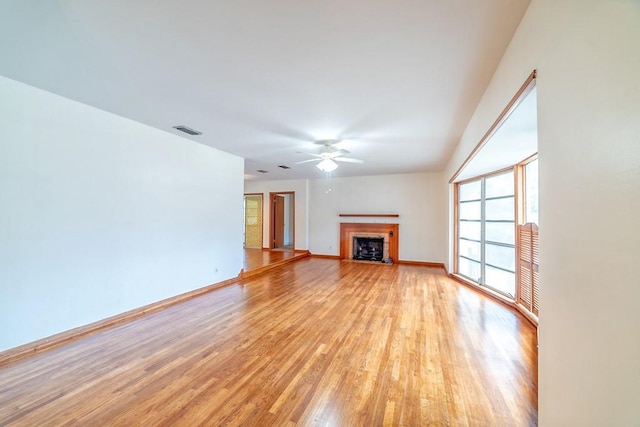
(340, 222), (399, 262)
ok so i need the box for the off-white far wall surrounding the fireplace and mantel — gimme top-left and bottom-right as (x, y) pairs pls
(309, 173), (446, 262)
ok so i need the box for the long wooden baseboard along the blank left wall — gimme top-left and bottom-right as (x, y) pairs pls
(0, 275), (240, 367)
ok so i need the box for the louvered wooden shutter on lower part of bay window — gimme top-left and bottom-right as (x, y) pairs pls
(517, 223), (540, 316)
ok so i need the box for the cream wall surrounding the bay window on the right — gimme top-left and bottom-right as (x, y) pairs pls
(444, 0), (640, 426)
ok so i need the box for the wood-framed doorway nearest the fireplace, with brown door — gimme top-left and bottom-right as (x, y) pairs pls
(269, 191), (295, 250)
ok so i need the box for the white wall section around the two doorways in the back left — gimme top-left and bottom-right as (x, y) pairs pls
(244, 179), (309, 250)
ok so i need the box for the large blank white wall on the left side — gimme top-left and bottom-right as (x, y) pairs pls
(0, 77), (243, 350)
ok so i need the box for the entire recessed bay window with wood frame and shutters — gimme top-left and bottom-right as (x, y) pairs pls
(449, 70), (540, 324)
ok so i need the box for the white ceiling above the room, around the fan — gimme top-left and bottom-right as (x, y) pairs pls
(0, 0), (529, 179)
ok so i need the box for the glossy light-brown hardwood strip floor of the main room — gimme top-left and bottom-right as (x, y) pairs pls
(0, 258), (537, 426)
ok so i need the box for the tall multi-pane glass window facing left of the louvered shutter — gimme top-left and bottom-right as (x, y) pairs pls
(458, 170), (516, 298)
